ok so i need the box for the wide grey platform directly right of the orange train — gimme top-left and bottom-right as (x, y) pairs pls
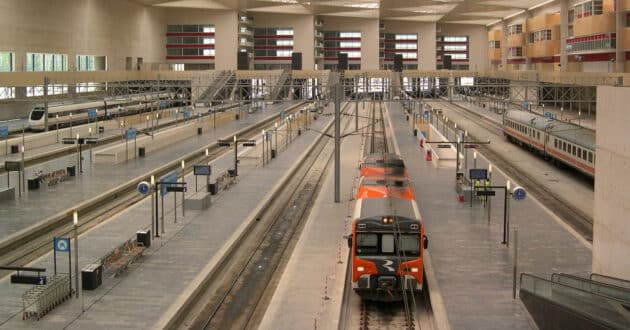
(388, 103), (591, 329)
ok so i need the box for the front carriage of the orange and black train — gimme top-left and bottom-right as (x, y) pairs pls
(348, 198), (428, 301)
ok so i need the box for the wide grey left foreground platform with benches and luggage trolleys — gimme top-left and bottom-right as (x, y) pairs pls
(0, 105), (332, 329)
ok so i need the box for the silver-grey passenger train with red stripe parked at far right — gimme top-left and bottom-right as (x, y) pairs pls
(503, 110), (596, 177)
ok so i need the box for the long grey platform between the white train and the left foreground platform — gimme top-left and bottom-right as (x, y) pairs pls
(0, 104), (294, 241)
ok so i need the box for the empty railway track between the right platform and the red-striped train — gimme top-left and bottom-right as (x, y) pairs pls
(428, 99), (593, 242)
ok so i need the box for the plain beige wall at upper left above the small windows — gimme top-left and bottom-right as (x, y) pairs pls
(0, 0), (166, 71)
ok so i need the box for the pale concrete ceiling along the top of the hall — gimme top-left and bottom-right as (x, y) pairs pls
(133, 0), (550, 25)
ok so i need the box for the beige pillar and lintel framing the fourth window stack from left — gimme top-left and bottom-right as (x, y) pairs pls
(383, 20), (435, 70)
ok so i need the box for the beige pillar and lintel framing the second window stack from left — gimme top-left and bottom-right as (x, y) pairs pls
(253, 13), (315, 70)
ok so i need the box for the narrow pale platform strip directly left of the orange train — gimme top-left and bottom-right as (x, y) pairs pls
(259, 102), (369, 330)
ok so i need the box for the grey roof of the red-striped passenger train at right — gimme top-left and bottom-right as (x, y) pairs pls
(505, 110), (595, 150)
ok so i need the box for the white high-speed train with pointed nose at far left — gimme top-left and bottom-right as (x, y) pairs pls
(28, 92), (180, 131)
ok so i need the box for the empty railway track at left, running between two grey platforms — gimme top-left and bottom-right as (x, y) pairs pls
(0, 103), (302, 277)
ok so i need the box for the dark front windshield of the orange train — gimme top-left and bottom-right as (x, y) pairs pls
(356, 233), (420, 257)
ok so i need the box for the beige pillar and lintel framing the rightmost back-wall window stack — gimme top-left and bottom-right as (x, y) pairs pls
(437, 24), (488, 70)
